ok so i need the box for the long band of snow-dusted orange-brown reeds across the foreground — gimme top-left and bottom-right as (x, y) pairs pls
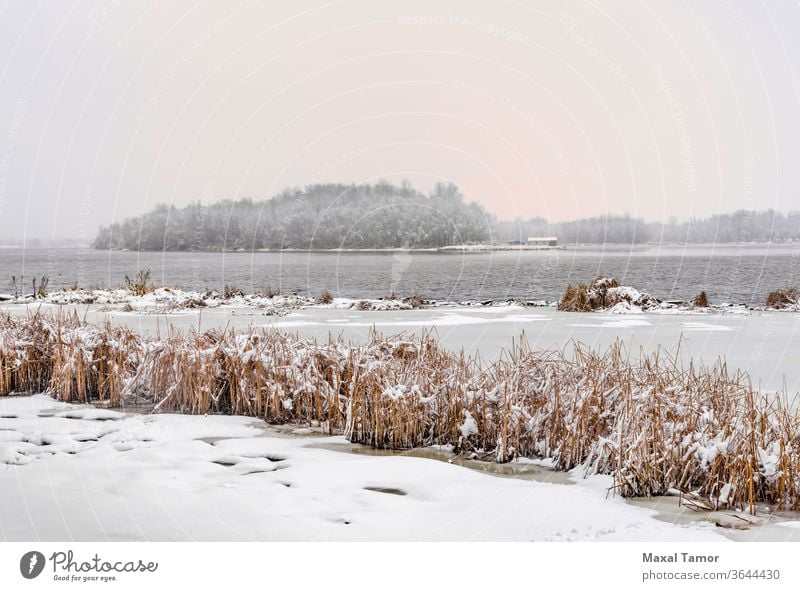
(0, 314), (800, 511)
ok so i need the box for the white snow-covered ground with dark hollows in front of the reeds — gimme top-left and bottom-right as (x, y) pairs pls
(0, 395), (748, 541)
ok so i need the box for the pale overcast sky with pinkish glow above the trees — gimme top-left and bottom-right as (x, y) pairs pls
(0, 0), (800, 242)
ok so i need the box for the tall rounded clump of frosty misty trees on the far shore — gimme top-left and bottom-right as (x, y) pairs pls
(94, 181), (495, 250)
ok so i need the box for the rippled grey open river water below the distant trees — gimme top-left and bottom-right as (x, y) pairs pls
(0, 244), (800, 304)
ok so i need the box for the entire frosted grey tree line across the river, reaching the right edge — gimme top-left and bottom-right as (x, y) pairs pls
(93, 181), (800, 251)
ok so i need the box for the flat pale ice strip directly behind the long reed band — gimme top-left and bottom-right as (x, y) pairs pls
(7, 305), (800, 393)
